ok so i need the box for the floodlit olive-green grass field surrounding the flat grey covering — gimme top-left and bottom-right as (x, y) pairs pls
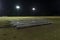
(0, 17), (60, 40)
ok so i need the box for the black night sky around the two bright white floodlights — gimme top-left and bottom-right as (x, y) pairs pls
(0, 0), (60, 16)
